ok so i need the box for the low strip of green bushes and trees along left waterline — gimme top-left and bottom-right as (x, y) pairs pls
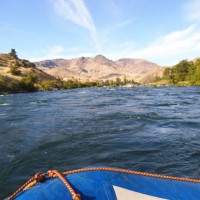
(0, 76), (140, 94)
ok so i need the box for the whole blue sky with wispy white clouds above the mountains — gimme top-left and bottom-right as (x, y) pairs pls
(0, 0), (200, 66)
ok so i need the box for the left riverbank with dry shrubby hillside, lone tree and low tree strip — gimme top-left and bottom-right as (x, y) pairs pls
(0, 49), (140, 94)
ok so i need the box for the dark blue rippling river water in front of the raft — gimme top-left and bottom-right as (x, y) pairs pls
(0, 87), (200, 197)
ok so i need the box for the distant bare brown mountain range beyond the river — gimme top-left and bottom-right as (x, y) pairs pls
(35, 55), (164, 83)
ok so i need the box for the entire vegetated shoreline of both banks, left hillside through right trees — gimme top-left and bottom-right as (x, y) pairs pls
(0, 49), (200, 94)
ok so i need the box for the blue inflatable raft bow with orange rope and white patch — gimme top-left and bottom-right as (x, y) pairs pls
(9, 168), (200, 200)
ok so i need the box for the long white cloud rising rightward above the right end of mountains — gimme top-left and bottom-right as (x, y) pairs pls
(110, 25), (200, 65)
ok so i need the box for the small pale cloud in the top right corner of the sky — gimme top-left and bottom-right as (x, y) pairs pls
(184, 0), (200, 21)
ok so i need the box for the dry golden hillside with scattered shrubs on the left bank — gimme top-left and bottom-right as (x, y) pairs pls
(0, 54), (57, 93)
